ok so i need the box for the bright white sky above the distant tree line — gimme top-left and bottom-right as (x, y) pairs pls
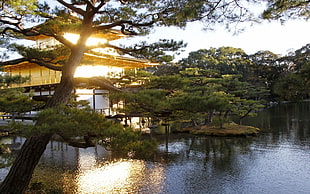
(145, 20), (310, 58)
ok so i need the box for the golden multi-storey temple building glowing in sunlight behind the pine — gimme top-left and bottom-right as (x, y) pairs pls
(4, 30), (156, 116)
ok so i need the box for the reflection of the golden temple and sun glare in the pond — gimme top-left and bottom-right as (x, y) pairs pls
(35, 142), (165, 193)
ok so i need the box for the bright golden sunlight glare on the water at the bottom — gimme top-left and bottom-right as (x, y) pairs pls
(76, 158), (164, 193)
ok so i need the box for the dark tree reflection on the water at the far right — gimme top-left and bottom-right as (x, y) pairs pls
(245, 102), (310, 145)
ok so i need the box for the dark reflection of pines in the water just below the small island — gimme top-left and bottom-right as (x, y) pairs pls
(156, 135), (253, 168)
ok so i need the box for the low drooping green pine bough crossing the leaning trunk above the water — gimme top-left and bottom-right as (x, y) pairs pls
(23, 106), (156, 154)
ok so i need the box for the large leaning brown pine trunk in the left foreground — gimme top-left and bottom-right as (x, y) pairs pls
(0, 10), (96, 194)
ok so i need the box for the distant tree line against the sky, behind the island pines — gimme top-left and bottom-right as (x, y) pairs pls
(153, 44), (310, 102)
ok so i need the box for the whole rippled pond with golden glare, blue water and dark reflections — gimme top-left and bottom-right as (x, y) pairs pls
(0, 102), (310, 194)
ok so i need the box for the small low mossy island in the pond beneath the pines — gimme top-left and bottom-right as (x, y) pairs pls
(178, 123), (260, 137)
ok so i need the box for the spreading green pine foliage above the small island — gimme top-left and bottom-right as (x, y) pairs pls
(113, 64), (264, 127)
